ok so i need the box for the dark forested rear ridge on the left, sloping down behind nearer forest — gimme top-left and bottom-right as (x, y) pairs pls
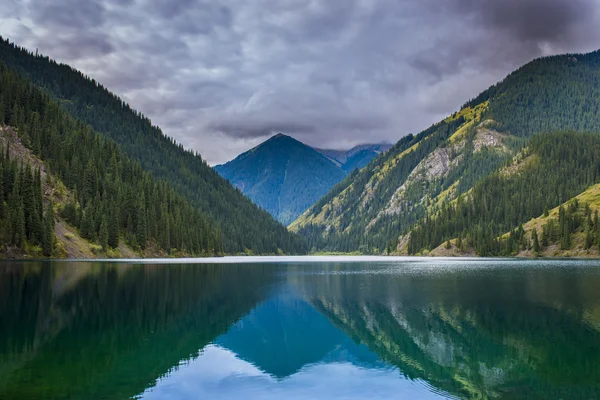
(0, 38), (306, 253)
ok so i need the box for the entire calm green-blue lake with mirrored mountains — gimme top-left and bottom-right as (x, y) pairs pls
(0, 258), (600, 400)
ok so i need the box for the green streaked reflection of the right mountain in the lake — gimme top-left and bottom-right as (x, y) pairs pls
(291, 263), (600, 399)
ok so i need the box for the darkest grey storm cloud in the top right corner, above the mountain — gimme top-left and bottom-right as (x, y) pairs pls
(410, 0), (600, 79)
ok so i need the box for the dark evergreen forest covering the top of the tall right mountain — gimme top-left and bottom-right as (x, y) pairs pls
(465, 50), (600, 138)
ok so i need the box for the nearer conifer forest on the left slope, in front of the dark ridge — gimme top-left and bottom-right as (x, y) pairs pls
(0, 64), (223, 256)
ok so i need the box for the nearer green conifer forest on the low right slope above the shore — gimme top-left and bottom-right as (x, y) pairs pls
(408, 133), (600, 255)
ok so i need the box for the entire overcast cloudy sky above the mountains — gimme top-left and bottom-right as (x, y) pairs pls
(0, 0), (600, 165)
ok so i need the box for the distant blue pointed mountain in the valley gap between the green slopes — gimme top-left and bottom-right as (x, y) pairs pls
(215, 134), (385, 225)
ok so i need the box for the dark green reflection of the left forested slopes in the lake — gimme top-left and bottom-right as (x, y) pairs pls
(0, 263), (272, 399)
